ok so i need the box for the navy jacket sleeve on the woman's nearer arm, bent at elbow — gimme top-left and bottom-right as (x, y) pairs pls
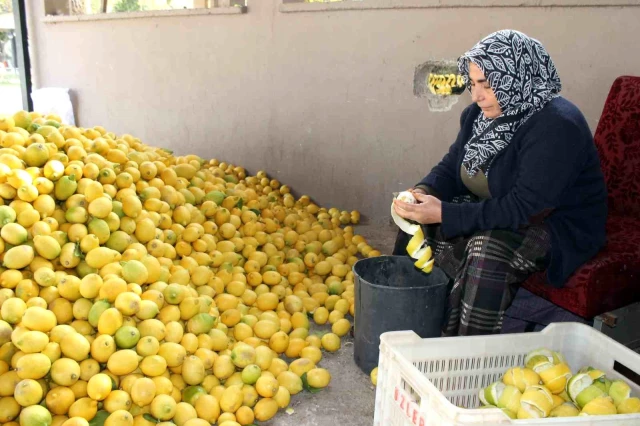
(442, 116), (586, 238)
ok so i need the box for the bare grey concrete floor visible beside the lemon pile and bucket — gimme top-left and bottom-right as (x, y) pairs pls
(260, 223), (397, 426)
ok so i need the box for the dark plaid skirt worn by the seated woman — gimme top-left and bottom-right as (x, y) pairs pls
(393, 210), (551, 336)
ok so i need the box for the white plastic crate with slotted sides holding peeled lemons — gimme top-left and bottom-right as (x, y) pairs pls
(374, 323), (640, 426)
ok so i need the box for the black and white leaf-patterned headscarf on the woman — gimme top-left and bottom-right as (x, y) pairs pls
(458, 30), (562, 176)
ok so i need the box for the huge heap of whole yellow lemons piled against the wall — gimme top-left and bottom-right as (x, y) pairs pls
(0, 111), (380, 426)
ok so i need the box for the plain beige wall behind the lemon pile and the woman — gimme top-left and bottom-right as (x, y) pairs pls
(25, 0), (640, 223)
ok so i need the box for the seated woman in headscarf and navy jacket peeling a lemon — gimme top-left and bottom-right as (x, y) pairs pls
(394, 30), (607, 336)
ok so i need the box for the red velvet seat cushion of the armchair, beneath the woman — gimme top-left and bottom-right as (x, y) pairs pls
(523, 215), (640, 318)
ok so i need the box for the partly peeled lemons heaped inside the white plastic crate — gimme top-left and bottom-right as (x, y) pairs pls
(478, 348), (640, 419)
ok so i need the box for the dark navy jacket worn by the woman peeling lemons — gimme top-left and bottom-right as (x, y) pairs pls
(418, 97), (607, 287)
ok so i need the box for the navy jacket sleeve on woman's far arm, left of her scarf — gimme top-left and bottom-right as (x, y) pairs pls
(416, 105), (473, 201)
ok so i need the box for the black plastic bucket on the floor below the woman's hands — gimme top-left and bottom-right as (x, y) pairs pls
(353, 256), (449, 374)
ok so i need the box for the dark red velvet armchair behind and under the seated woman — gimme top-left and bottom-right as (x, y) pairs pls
(523, 76), (640, 319)
